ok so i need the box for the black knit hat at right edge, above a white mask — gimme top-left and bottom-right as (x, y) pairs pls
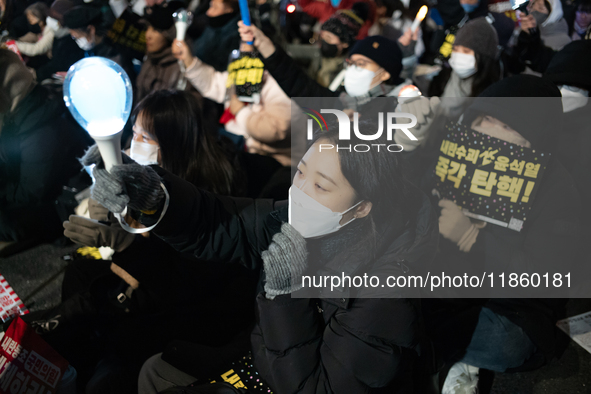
(544, 40), (591, 91)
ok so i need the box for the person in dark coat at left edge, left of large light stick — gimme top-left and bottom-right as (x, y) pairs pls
(0, 49), (90, 243)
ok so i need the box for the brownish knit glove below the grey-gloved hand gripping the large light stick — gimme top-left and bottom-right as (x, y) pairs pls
(64, 215), (135, 252)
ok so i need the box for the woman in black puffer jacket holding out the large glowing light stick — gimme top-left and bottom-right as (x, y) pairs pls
(80, 116), (437, 394)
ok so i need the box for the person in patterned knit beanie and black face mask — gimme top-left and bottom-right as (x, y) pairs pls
(312, 2), (368, 86)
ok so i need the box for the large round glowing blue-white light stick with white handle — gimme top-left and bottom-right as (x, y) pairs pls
(64, 56), (133, 171)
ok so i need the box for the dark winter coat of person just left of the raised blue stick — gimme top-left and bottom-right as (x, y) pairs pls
(193, 14), (240, 71)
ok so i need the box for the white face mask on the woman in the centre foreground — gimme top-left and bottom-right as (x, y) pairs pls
(288, 185), (362, 238)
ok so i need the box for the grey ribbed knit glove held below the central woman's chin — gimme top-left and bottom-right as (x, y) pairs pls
(262, 223), (307, 300)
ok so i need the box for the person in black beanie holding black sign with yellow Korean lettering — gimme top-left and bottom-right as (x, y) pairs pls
(420, 75), (584, 394)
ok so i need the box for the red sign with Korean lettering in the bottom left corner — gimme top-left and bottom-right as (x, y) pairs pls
(0, 317), (68, 394)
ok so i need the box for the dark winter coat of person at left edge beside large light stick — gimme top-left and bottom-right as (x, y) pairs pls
(0, 86), (88, 240)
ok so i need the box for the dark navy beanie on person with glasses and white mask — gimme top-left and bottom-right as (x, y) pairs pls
(349, 36), (402, 83)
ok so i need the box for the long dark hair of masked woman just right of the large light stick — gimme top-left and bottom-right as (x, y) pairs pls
(134, 90), (238, 195)
